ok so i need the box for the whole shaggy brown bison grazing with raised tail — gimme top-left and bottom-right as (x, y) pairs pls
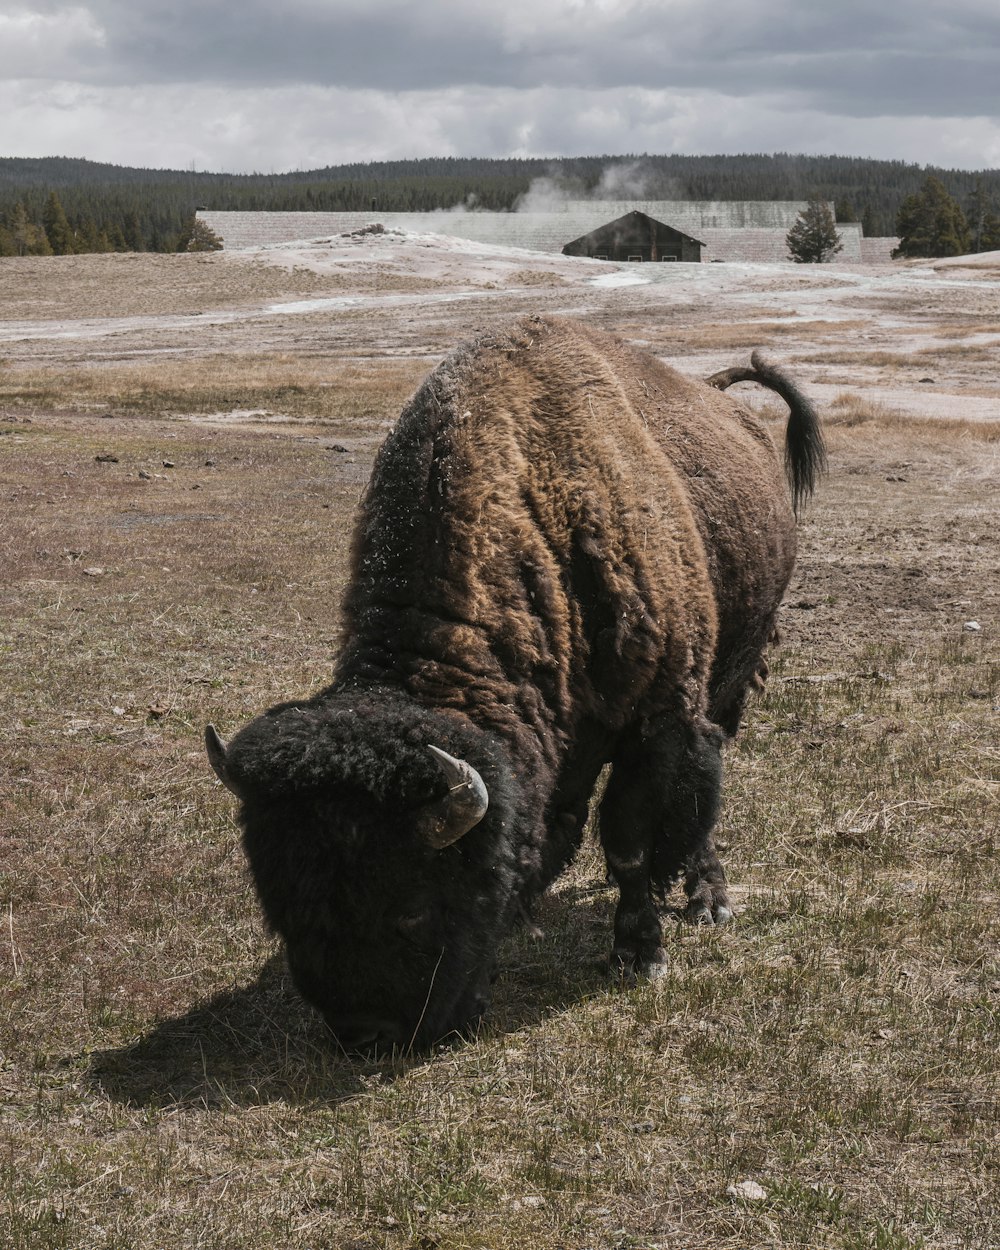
(208, 310), (823, 1049)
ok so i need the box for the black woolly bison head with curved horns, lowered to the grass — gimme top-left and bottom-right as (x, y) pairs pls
(206, 695), (516, 1050)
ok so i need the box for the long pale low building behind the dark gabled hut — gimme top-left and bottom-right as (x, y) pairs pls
(198, 200), (896, 264)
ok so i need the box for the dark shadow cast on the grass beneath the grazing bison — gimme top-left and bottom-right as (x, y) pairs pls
(90, 885), (614, 1108)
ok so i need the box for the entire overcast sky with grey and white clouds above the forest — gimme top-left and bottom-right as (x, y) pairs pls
(0, 0), (1000, 173)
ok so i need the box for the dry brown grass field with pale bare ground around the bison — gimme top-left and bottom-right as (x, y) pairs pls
(0, 239), (1000, 1250)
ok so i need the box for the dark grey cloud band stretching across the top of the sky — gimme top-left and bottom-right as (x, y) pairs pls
(9, 0), (1000, 116)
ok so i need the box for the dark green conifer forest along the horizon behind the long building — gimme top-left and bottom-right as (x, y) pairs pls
(0, 153), (1000, 255)
